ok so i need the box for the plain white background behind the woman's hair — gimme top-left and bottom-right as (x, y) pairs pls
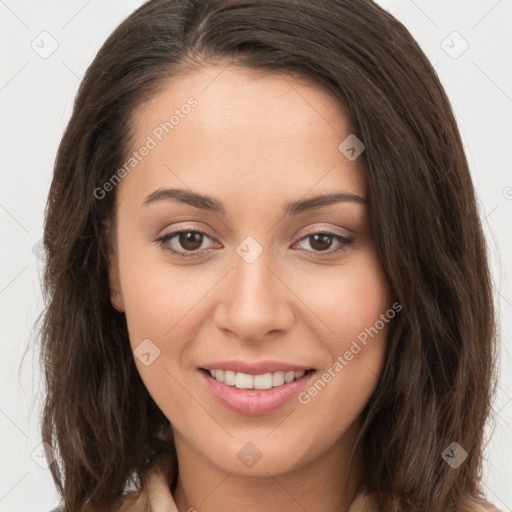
(0, 0), (512, 512)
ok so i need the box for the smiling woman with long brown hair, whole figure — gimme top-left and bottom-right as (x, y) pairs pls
(42, 0), (496, 512)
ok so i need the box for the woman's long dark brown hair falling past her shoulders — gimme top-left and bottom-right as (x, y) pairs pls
(37, 0), (496, 512)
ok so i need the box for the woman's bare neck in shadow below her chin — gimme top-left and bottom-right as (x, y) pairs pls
(174, 422), (362, 512)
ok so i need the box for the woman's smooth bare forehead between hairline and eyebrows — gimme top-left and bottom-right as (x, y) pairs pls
(121, 66), (365, 206)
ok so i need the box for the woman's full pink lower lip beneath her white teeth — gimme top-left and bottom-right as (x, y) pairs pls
(199, 370), (314, 416)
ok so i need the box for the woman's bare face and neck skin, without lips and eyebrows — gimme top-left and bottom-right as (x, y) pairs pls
(110, 65), (392, 512)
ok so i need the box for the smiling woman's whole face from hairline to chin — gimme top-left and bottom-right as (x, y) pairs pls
(111, 66), (394, 475)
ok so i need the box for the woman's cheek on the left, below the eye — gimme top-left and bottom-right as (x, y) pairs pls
(119, 244), (211, 411)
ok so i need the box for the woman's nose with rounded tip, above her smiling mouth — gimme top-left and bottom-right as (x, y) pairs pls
(214, 245), (295, 342)
